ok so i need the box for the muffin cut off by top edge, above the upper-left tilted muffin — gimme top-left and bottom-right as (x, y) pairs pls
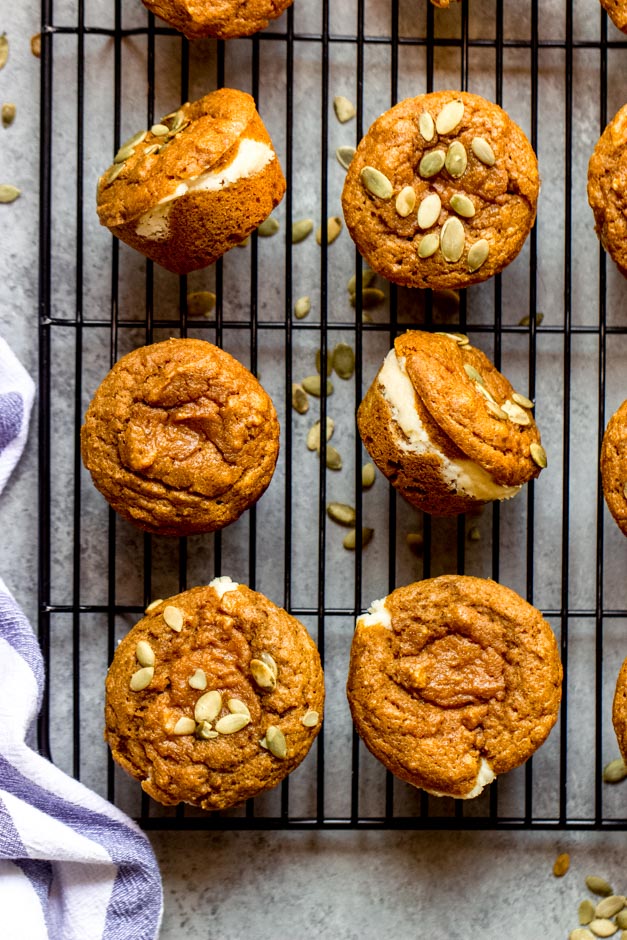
(142, 0), (293, 39)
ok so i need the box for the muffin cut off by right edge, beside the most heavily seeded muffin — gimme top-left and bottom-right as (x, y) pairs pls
(588, 104), (627, 277)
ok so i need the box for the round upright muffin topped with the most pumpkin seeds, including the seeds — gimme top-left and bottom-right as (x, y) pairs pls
(342, 91), (539, 288)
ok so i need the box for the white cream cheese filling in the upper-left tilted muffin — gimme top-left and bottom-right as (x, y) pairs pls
(135, 137), (275, 241)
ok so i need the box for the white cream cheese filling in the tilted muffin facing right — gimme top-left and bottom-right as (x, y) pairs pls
(378, 349), (522, 500)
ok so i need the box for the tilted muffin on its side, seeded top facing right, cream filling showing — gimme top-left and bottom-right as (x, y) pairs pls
(357, 330), (546, 515)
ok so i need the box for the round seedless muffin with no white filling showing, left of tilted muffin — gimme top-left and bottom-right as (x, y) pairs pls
(81, 339), (279, 535)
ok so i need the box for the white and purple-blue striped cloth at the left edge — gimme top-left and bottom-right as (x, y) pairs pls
(0, 339), (163, 940)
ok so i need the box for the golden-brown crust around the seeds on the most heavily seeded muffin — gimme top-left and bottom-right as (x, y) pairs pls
(342, 91), (539, 288)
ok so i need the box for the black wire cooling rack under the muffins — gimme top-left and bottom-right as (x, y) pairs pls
(39, 0), (627, 829)
